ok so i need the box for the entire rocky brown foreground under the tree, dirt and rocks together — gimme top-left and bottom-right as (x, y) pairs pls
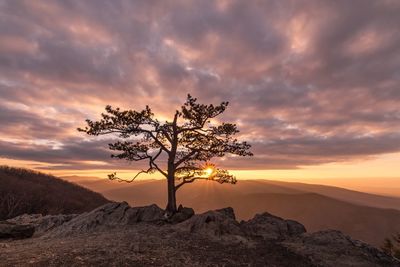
(0, 203), (400, 267)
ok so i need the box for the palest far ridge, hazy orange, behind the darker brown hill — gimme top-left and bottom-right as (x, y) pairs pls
(66, 176), (400, 213)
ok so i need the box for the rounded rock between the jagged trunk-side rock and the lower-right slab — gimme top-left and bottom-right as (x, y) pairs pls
(240, 212), (306, 240)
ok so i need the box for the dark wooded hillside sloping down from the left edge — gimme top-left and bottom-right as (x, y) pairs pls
(0, 166), (109, 220)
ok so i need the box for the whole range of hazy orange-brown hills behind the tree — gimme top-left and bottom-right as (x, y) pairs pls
(69, 180), (400, 246)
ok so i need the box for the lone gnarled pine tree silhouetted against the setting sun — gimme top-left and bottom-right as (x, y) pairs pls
(78, 95), (252, 214)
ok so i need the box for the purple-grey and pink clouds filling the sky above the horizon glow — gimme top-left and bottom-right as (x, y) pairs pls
(0, 0), (400, 180)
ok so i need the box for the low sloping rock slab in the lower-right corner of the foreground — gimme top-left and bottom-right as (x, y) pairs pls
(281, 230), (400, 267)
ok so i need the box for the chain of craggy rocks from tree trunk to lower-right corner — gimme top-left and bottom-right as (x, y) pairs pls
(176, 208), (400, 267)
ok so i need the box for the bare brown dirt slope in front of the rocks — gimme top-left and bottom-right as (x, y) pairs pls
(0, 224), (312, 267)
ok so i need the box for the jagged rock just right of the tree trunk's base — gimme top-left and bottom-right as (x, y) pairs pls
(177, 208), (243, 239)
